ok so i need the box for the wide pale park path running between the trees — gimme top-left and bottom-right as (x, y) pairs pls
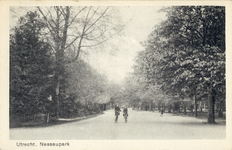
(10, 109), (226, 140)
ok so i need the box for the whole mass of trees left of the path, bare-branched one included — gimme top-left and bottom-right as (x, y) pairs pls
(10, 6), (122, 124)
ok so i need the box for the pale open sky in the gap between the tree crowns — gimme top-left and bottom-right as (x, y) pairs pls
(88, 6), (165, 83)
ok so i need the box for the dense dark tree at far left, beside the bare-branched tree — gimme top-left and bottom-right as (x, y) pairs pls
(10, 12), (52, 118)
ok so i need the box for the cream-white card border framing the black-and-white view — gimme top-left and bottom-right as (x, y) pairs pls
(0, 0), (232, 150)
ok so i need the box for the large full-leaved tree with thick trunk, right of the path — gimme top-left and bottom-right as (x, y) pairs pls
(130, 6), (225, 123)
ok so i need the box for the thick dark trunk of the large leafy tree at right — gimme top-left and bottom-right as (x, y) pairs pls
(208, 87), (215, 124)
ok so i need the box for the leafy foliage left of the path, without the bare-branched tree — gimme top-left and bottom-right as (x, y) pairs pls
(10, 12), (114, 118)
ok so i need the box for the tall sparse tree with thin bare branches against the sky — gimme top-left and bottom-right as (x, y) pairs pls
(37, 6), (123, 118)
